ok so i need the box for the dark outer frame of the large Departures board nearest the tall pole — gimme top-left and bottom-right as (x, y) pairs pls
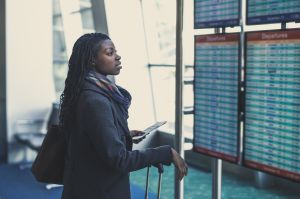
(192, 32), (242, 164)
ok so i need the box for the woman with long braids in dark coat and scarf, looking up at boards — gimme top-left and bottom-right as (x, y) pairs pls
(60, 33), (187, 199)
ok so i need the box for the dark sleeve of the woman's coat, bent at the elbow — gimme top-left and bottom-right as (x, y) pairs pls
(80, 96), (172, 172)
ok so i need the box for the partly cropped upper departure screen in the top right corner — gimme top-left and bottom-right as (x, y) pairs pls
(247, 0), (300, 25)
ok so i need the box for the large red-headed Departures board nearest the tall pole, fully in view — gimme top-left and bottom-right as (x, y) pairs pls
(193, 34), (240, 163)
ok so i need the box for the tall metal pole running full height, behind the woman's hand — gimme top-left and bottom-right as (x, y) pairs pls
(174, 0), (184, 199)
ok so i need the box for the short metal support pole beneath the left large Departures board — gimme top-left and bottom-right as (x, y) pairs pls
(212, 158), (222, 199)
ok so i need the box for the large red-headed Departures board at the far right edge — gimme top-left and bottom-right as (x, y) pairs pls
(244, 29), (300, 181)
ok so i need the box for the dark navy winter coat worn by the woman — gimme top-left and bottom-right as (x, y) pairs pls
(62, 81), (172, 199)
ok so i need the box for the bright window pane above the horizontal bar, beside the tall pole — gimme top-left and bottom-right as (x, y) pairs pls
(142, 0), (176, 65)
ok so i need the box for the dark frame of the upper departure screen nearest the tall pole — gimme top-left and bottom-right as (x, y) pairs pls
(194, 0), (242, 29)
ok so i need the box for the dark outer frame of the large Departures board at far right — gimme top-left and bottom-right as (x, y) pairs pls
(242, 28), (300, 182)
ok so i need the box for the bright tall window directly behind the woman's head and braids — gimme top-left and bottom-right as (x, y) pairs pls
(53, 0), (95, 100)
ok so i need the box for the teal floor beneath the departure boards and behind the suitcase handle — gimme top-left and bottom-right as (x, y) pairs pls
(131, 166), (300, 199)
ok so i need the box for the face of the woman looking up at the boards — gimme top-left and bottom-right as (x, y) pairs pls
(94, 39), (122, 75)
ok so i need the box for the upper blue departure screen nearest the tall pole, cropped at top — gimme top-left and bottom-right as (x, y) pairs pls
(194, 0), (240, 29)
